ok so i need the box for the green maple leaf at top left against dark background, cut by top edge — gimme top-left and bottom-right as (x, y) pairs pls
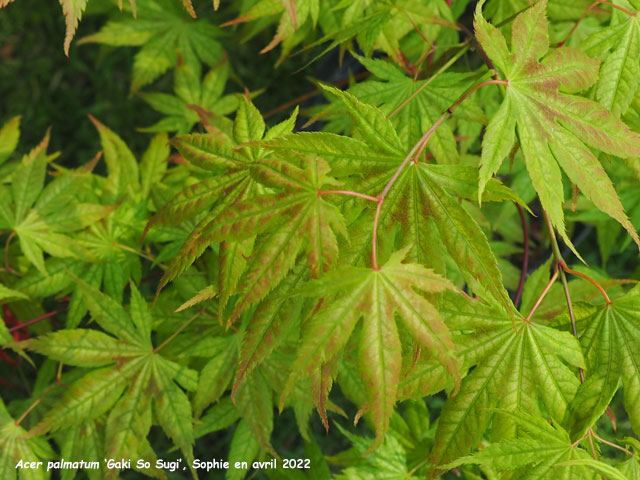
(78, 0), (223, 91)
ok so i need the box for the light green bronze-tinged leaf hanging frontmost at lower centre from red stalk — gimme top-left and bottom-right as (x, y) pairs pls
(281, 249), (460, 451)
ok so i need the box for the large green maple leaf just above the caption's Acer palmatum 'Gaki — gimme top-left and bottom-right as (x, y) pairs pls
(25, 280), (197, 476)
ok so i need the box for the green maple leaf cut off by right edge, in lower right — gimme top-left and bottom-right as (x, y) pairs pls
(568, 287), (640, 437)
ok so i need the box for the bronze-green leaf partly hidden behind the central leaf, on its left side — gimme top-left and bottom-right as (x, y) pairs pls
(152, 97), (297, 296)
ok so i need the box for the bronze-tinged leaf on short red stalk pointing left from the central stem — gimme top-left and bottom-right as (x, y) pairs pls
(225, 158), (347, 322)
